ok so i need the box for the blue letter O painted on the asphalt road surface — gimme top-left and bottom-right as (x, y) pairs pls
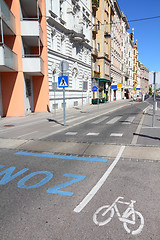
(17, 171), (53, 189)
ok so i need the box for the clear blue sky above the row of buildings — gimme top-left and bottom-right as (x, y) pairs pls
(117, 0), (160, 72)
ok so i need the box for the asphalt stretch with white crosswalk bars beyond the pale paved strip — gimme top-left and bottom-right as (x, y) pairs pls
(43, 102), (147, 144)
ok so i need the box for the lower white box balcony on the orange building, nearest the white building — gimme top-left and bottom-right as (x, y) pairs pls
(23, 55), (44, 76)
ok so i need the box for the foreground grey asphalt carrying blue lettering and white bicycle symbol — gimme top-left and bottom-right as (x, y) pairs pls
(0, 149), (160, 240)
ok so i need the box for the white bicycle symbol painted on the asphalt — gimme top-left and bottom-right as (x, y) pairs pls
(93, 197), (144, 235)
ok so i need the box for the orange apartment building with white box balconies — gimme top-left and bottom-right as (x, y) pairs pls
(0, 0), (49, 116)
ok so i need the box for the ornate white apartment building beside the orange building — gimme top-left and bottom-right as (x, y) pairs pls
(46, 0), (92, 111)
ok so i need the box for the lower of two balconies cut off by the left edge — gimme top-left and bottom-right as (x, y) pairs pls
(0, 45), (18, 72)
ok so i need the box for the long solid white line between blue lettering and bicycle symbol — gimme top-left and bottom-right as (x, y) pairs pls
(73, 146), (125, 213)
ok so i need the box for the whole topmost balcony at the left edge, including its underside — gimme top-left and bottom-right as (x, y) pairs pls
(0, 0), (16, 35)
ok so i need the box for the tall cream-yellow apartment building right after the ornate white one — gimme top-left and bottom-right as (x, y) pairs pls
(93, 0), (113, 99)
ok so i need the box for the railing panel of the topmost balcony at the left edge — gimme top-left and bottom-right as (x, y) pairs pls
(0, 0), (16, 34)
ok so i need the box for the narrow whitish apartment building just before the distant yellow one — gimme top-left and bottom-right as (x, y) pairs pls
(121, 12), (133, 99)
